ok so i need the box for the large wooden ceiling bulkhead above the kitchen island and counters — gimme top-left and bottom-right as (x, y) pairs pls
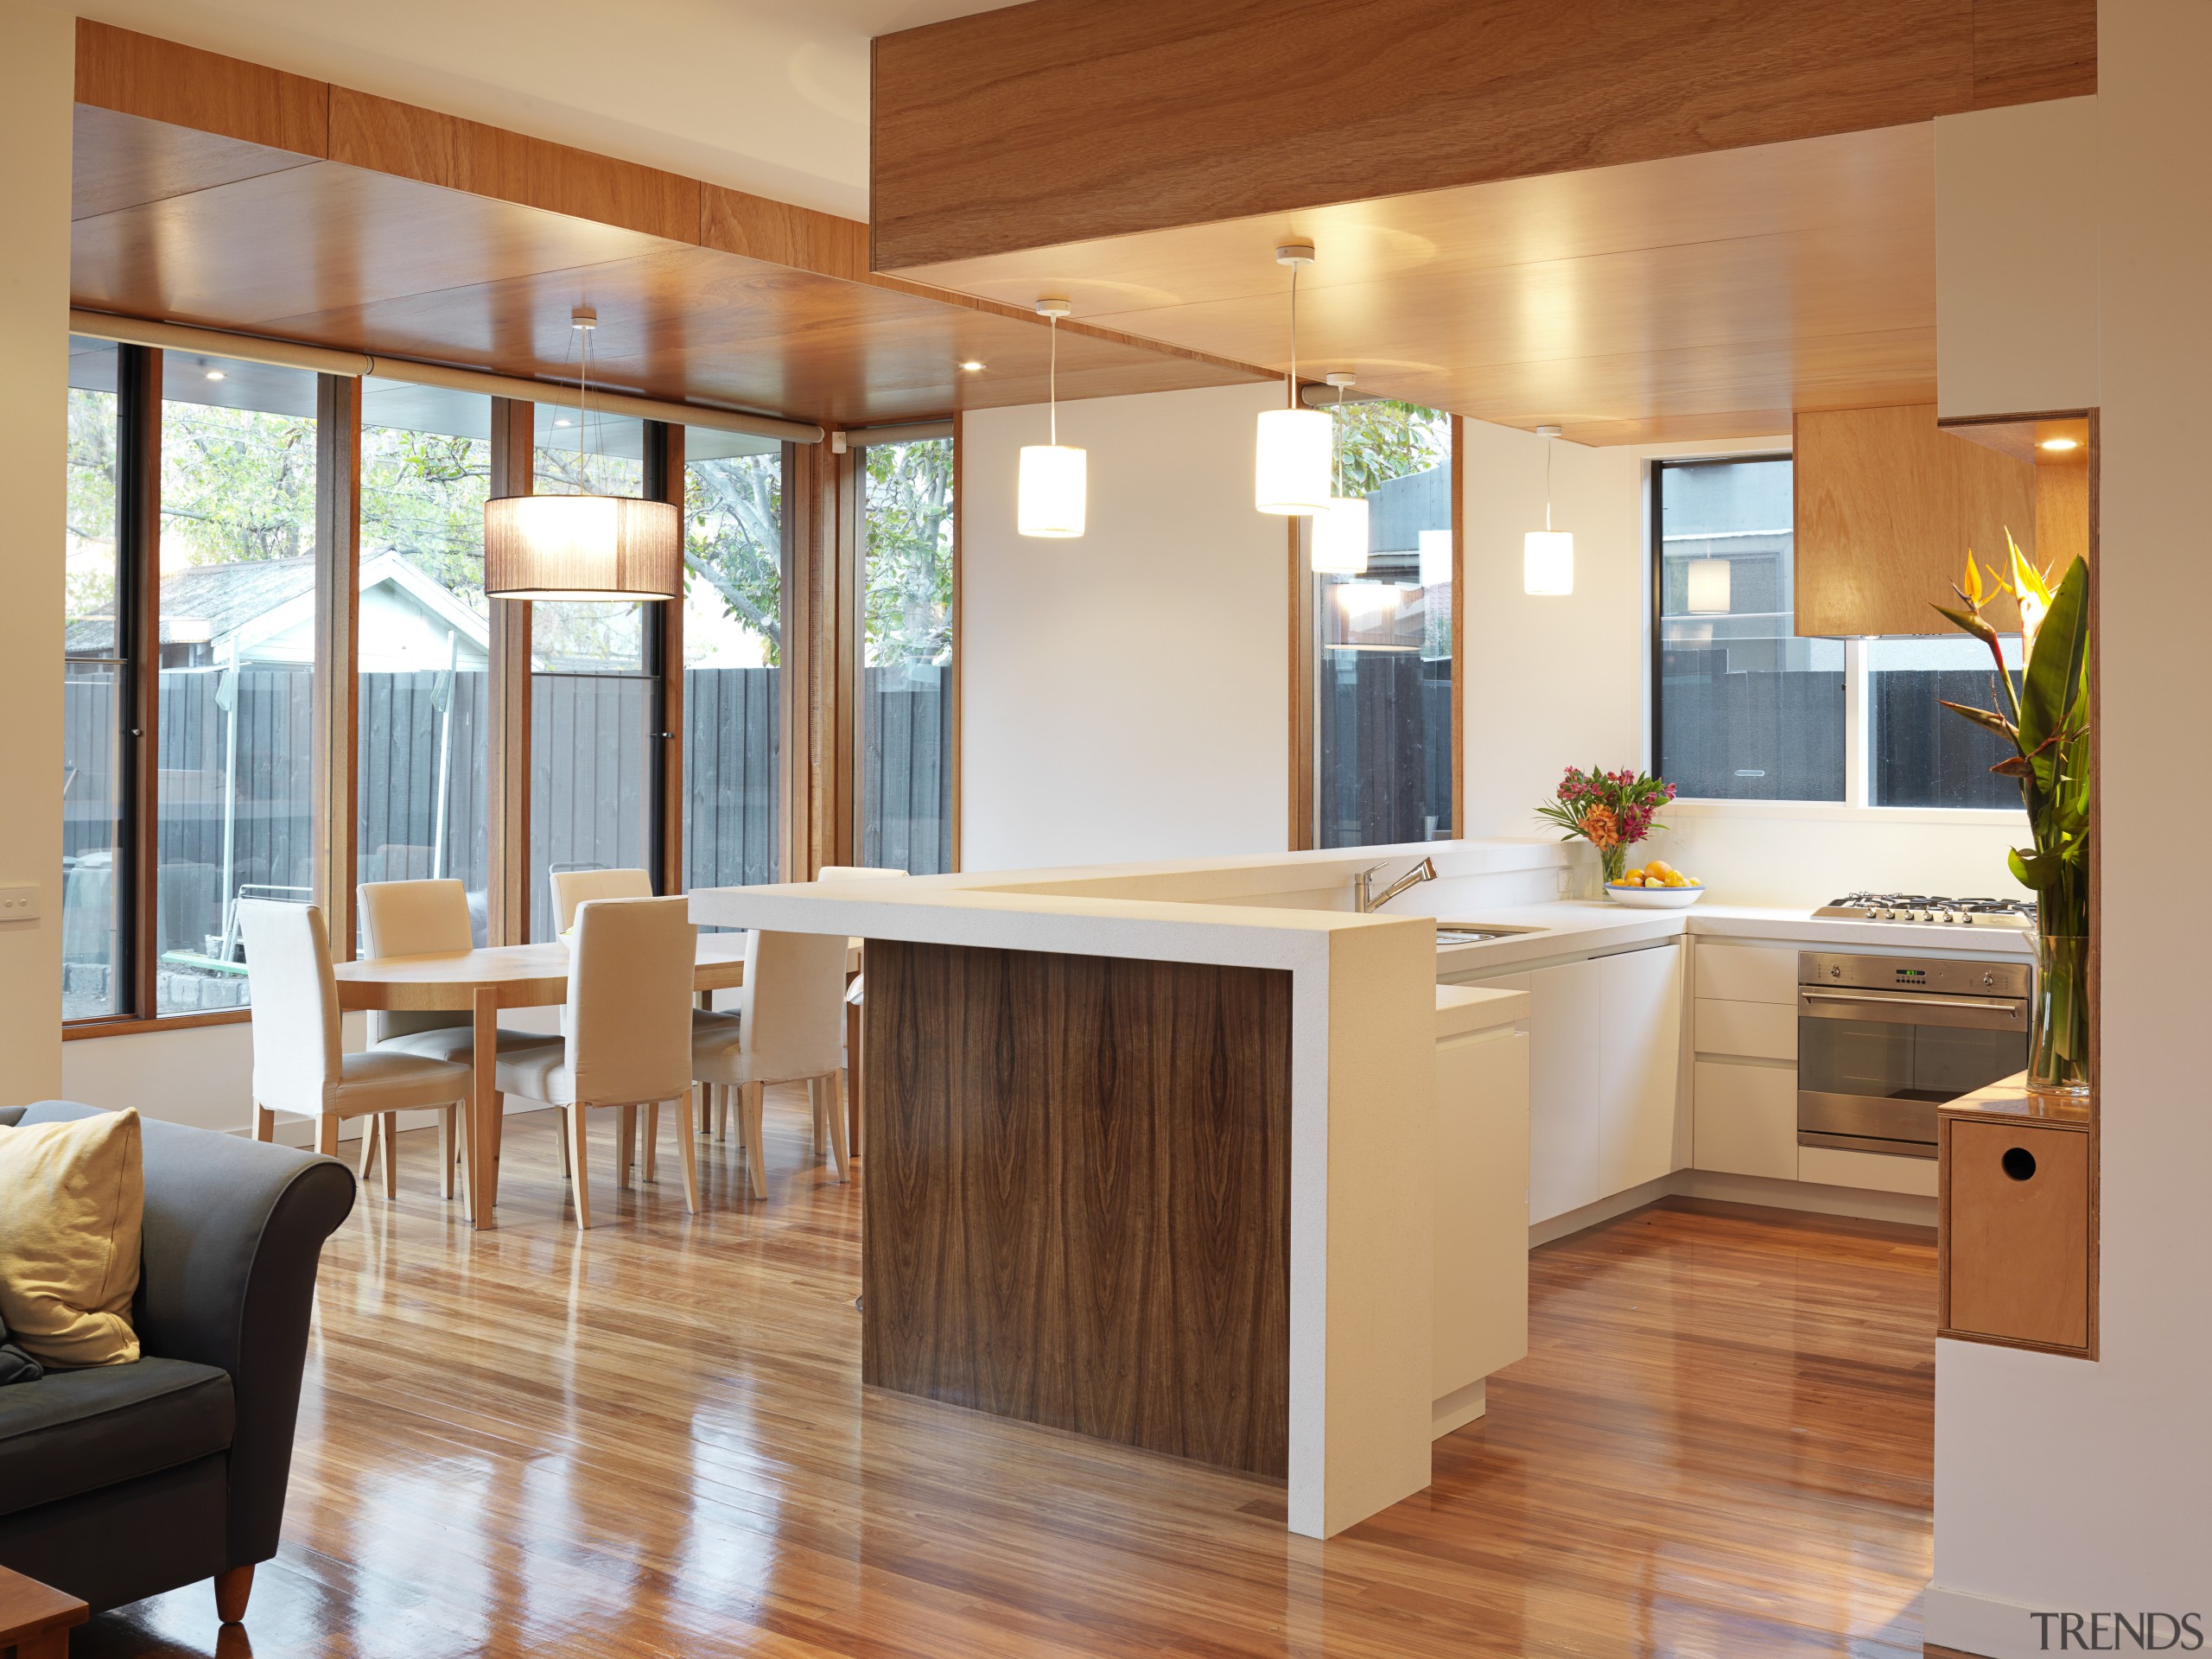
(872, 0), (2097, 442)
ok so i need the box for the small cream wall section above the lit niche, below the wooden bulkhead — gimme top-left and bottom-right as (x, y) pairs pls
(1936, 98), (2097, 418)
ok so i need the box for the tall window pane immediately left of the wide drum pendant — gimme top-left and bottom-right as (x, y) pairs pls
(354, 378), (491, 944)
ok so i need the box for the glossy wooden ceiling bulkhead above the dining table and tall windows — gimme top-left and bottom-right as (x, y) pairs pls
(71, 20), (1259, 427)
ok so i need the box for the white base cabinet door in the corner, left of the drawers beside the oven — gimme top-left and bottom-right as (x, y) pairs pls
(1597, 944), (1681, 1197)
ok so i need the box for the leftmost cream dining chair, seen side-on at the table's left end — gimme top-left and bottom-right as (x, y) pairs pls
(238, 898), (475, 1197)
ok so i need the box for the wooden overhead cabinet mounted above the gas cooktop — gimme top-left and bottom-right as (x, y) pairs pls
(1796, 403), (2037, 637)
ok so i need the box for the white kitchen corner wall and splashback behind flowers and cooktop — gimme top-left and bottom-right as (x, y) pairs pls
(1465, 420), (2022, 907)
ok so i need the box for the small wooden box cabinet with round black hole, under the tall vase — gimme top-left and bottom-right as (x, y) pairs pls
(1936, 1079), (2097, 1358)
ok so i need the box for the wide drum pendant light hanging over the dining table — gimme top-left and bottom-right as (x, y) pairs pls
(485, 305), (683, 601)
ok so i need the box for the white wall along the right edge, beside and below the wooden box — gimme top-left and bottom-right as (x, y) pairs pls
(1927, 0), (2212, 1659)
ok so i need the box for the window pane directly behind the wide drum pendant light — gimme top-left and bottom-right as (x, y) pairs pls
(531, 403), (661, 940)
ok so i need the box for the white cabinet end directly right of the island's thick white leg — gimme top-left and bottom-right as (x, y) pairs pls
(1431, 1027), (1529, 1433)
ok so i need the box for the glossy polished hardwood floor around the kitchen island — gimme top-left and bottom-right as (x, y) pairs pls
(71, 1090), (1936, 1659)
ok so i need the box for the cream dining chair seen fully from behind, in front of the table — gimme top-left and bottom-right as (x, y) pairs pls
(498, 898), (699, 1228)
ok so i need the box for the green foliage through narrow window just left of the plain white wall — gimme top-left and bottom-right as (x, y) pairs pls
(862, 448), (953, 664)
